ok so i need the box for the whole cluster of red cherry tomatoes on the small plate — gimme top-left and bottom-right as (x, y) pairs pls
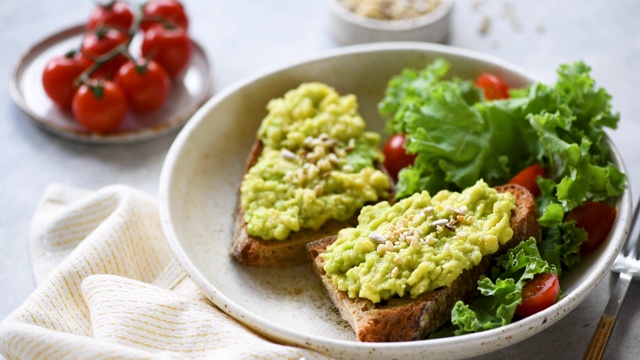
(42, 0), (192, 133)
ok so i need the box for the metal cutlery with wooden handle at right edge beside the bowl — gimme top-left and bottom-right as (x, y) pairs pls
(582, 199), (640, 360)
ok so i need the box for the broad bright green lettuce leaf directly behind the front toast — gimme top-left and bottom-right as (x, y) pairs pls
(397, 82), (539, 198)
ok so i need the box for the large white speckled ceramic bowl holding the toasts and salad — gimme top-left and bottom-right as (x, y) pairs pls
(160, 43), (631, 359)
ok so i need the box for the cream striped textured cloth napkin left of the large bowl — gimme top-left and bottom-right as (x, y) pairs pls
(0, 185), (325, 360)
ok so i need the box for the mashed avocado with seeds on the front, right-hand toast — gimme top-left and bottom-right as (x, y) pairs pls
(321, 180), (515, 302)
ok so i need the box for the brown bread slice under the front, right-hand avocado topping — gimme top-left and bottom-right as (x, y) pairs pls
(307, 185), (541, 342)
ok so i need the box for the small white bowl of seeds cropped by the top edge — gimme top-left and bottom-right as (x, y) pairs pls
(328, 0), (454, 45)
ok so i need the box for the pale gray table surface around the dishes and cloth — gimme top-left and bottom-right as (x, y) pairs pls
(0, 0), (640, 359)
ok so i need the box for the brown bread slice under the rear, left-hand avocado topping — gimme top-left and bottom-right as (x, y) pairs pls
(231, 141), (393, 268)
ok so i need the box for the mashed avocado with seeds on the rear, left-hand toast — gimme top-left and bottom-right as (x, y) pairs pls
(240, 83), (390, 240)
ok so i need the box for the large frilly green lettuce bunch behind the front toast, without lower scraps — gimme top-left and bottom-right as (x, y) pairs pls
(379, 59), (626, 201)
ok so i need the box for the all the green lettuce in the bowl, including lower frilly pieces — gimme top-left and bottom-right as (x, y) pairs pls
(379, 59), (626, 334)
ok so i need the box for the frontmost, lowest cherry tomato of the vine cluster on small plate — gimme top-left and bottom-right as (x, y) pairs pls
(72, 81), (127, 133)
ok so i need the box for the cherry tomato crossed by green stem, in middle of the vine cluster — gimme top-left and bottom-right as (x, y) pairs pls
(82, 29), (129, 79)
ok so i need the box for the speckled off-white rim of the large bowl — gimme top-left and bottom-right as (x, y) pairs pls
(159, 42), (632, 358)
